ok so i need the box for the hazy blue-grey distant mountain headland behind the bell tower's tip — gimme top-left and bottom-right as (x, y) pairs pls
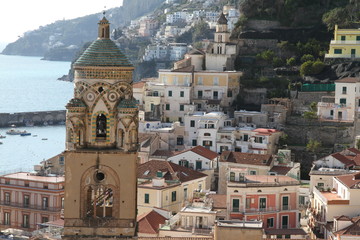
(2, 0), (164, 61)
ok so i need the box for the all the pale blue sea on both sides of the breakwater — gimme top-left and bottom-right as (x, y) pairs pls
(0, 54), (74, 174)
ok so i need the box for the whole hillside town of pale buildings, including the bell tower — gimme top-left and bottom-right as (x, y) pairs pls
(0, 0), (360, 240)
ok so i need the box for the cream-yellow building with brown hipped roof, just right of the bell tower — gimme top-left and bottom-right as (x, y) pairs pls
(137, 160), (207, 214)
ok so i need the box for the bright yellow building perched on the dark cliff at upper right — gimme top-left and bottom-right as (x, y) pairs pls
(325, 25), (360, 59)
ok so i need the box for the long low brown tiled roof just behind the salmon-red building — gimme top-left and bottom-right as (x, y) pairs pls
(220, 151), (273, 166)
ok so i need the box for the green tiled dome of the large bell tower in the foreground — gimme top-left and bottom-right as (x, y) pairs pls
(74, 38), (132, 67)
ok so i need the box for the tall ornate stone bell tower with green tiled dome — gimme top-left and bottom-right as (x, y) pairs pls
(63, 16), (138, 239)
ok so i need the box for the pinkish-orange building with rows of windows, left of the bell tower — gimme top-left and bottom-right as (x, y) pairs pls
(0, 172), (64, 231)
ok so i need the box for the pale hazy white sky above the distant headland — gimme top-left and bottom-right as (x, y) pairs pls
(0, 0), (122, 47)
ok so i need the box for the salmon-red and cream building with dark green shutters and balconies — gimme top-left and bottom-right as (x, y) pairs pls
(227, 175), (300, 229)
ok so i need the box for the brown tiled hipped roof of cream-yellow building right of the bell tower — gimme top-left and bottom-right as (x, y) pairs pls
(137, 160), (207, 182)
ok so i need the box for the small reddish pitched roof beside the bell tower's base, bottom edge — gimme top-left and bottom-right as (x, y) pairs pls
(137, 210), (167, 234)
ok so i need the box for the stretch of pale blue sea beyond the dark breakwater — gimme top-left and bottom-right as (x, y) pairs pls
(0, 55), (74, 113)
